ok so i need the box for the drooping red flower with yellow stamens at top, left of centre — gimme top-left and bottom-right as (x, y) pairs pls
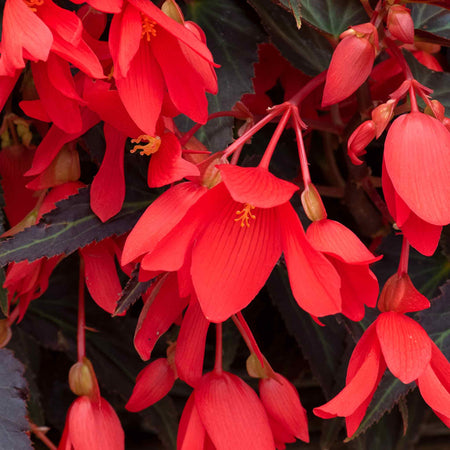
(109, 0), (217, 136)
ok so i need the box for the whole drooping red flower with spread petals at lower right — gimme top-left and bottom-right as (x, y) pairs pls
(314, 274), (450, 437)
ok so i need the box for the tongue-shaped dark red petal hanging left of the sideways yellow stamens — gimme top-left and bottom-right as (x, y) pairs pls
(91, 123), (127, 222)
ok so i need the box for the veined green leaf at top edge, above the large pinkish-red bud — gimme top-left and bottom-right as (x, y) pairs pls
(302, 0), (369, 38)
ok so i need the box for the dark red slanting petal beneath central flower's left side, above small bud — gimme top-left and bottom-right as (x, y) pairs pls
(134, 272), (188, 361)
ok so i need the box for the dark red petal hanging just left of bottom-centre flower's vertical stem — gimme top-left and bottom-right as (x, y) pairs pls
(175, 298), (209, 387)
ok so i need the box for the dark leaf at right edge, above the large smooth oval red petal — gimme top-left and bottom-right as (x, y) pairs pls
(405, 52), (450, 110)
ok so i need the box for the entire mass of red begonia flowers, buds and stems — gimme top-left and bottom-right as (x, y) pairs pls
(0, 0), (450, 450)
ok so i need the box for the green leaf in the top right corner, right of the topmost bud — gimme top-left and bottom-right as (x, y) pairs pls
(411, 4), (450, 42)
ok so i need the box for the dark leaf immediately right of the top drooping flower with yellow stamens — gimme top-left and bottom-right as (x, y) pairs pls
(177, 0), (266, 152)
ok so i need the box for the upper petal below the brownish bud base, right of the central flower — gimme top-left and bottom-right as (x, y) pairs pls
(306, 219), (381, 264)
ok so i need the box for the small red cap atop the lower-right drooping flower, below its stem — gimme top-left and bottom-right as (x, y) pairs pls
(378, 273), (430, 313)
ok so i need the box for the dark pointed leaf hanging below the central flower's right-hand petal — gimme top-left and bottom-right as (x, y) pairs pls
(267, 265), (346, 396)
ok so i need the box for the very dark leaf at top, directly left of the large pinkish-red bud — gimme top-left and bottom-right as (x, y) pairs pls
(248, 0), (332, 76)
